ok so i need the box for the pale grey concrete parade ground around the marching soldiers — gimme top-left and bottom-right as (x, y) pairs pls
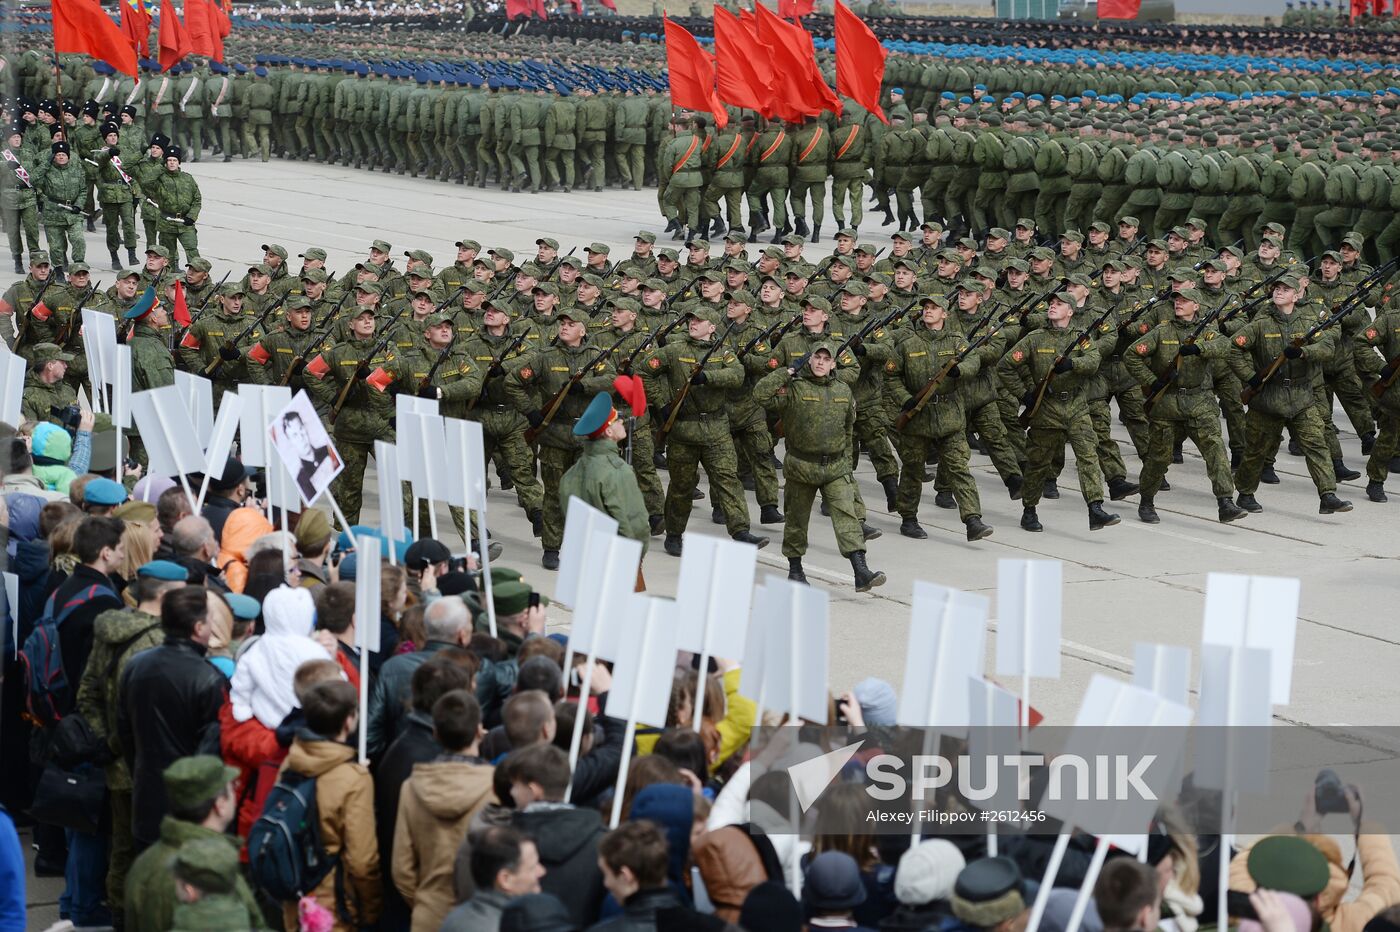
(6, 153), (1400, 725)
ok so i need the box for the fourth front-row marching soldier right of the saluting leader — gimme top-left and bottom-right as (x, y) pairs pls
(1228, 273), (1351, 515)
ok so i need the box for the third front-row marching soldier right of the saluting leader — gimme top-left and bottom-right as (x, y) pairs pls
(1123, 288), (1249, 525)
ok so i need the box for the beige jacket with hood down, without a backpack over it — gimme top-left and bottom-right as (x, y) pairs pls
(392, 758), (496, 932)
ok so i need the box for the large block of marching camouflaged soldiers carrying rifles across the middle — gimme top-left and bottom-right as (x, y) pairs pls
(4, 218), (1400, 589)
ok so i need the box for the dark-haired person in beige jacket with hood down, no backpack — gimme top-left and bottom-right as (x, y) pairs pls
(391, 685), (494, 932)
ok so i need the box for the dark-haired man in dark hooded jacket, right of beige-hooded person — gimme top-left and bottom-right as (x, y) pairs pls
(507, 744), (607, 925)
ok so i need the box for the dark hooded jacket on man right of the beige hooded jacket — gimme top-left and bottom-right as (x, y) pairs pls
(511, 806), (606, 928)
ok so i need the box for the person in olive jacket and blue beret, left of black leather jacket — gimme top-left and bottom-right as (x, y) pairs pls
(77, 560), (186, 915)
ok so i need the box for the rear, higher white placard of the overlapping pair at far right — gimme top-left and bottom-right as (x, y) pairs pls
(1201, 572), (1302, 705)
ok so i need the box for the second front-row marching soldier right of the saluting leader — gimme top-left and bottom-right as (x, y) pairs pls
(997, 291), (1119, 532)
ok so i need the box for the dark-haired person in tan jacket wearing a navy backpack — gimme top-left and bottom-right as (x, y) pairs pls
(283, 674), (381, 929)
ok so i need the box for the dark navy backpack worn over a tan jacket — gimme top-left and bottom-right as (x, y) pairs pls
(248, 770), (344, 912)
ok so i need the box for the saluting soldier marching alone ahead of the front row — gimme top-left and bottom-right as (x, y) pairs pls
(755, 341), (885, 592)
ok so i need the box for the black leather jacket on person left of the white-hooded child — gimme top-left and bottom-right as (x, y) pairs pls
(116, 637), (228, 847)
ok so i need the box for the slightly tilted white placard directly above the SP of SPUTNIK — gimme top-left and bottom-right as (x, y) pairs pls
(896, 581), (991, 736)
